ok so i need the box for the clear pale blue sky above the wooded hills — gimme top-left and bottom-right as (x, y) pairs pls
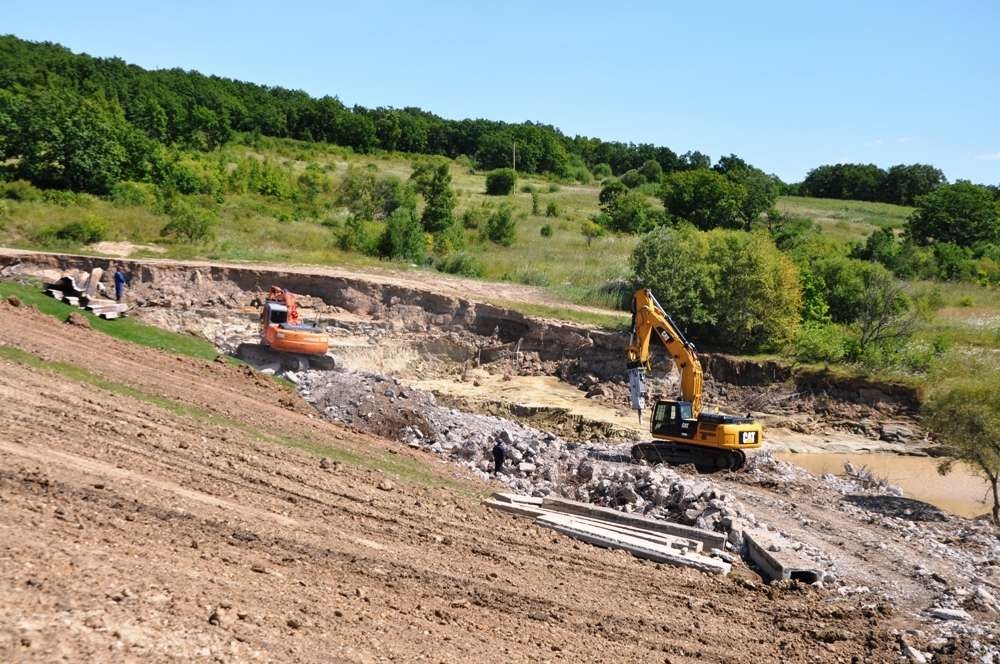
(0, 0), (1000, 184)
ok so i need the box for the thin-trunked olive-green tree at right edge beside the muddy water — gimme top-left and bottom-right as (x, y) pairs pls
(921, 354), (1000, 527)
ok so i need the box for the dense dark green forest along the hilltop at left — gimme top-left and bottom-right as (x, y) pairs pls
(0, 36), (709, 193)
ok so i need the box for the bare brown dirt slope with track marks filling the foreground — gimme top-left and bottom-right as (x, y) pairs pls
(0, 304), (897, 662)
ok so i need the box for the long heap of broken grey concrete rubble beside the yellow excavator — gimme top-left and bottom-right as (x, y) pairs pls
(298, 371), (832, 564)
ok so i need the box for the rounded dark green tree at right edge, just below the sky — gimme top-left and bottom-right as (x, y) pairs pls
(906, 180), (1000, 247)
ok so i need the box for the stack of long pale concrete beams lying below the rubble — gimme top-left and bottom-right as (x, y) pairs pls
(484, 493), (732, 575)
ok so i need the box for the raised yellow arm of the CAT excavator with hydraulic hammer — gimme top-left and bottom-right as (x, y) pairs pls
(626, 288), (703, 422)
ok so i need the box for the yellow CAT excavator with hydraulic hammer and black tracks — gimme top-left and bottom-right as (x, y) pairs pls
(626, 288), (763, 473)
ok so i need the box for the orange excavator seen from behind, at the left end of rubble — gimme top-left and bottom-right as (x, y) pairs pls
(236, 286), (334, 371)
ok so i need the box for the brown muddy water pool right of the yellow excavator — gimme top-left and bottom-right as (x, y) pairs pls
(775, 452), (990, 516)
